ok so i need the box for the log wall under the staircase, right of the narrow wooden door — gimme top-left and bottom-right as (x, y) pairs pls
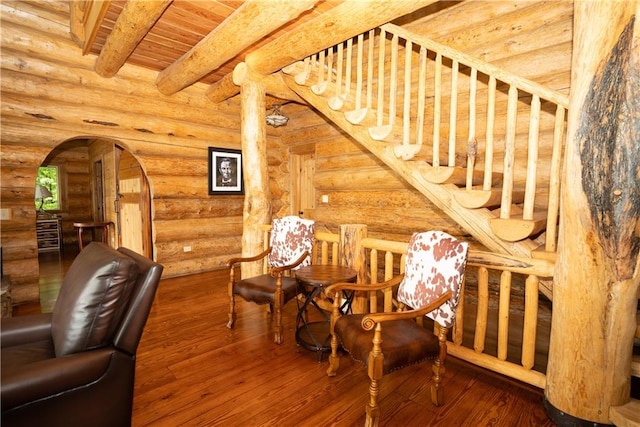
(282, 106), (466, 246)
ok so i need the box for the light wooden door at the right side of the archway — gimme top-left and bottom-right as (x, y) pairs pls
(116, 151), (152, 258)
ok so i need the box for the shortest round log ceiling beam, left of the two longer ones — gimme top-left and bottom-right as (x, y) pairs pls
(95, 0), (173, 77)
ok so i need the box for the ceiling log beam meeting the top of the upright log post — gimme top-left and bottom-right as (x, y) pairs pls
(245, 0), (438, 75)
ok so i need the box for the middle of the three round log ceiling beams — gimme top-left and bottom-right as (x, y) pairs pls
(156, 0), (318, 95)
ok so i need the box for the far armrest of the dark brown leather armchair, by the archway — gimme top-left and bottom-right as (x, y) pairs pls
(0, 313), (51, 350)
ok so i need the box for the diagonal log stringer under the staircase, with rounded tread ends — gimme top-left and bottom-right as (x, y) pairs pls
(282, 73), (551, 288)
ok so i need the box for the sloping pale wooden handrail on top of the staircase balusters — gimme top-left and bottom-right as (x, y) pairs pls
(380, 24), (569, 108)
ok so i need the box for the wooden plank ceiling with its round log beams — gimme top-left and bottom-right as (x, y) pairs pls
(70, 0), (436, 100)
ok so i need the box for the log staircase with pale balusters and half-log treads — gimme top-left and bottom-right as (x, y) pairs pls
(282, 24), (568, 298)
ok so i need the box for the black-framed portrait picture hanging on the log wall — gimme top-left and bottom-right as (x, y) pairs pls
(209, 147), (244, 195)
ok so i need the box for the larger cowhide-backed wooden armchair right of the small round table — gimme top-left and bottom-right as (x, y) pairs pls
(326, 231), (469, 426)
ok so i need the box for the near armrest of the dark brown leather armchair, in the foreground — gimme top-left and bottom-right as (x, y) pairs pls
(0, 347), (115, 411)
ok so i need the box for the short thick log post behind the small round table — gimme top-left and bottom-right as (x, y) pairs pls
(338, 224), (367, 313)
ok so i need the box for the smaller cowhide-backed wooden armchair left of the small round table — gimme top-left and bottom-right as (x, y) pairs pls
(227, 216), (315, 344)
